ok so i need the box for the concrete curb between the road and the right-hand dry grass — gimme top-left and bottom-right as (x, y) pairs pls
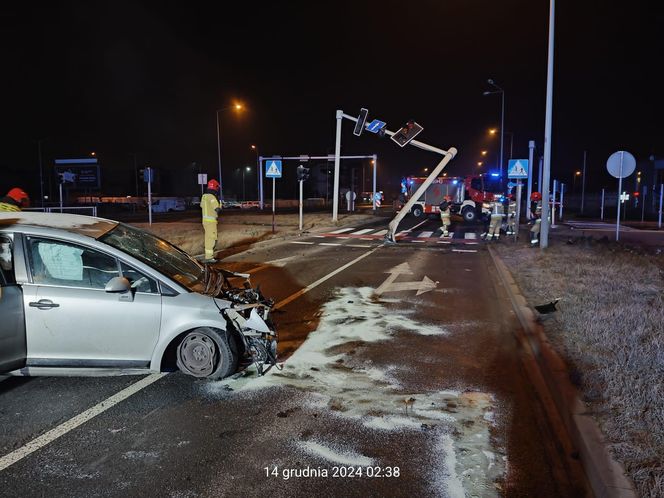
(488, 247), (637, 498)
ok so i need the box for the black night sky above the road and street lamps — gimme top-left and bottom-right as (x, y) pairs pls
(0, 0), (664, 199)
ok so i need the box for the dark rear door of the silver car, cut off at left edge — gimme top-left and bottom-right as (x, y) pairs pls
(0, 234), (26, 373)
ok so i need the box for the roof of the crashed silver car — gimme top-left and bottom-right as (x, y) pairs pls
(0, 211), (119, 239)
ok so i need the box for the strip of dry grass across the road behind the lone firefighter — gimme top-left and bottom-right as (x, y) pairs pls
(134, 213), (378, 255)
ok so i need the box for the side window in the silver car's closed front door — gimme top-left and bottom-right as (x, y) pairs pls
(28, 237), (120, 289)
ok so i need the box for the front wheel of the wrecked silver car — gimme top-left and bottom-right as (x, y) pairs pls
(176, 327), (237, 379)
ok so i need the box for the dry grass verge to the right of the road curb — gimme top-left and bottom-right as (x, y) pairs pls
(499, 242), (664, 497)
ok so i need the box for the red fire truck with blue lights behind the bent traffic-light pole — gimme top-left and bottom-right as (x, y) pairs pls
(401, 174), (502, 223)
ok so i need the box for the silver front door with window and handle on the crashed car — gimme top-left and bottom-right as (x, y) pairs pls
(23, 236), (161, 368)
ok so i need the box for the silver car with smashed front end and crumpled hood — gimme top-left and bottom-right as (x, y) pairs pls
(0, 212), (277, 379)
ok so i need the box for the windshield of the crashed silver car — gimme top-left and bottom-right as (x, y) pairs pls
(99, 223), (204, 292)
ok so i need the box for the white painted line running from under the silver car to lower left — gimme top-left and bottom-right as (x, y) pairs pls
(0, 373), (166, 471)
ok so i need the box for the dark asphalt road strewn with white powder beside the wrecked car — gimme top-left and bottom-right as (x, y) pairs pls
(0, 218), (582, 497)
